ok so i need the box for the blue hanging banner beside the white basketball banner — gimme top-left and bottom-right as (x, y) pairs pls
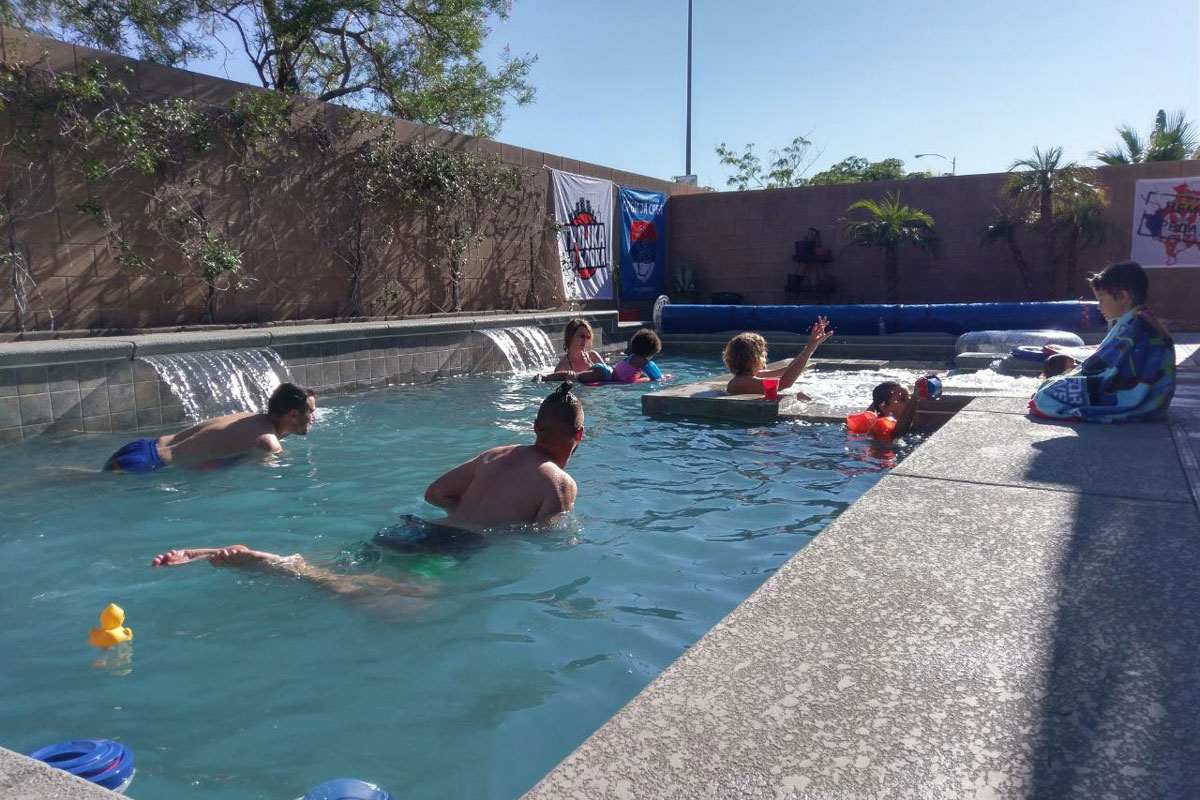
(617, 186), (667, 300)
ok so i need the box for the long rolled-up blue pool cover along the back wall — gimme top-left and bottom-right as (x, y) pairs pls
(661, 300), (1105, 336)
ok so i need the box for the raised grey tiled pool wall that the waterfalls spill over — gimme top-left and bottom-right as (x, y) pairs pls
(0, 312), (617, 446)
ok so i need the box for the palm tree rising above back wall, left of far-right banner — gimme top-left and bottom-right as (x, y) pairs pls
(1001, 148), (1100, 296)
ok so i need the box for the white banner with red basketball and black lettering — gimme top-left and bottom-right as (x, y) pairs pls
(550, 169), (612, 300)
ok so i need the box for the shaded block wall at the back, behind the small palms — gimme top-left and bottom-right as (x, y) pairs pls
(670, 161), (1200, 329)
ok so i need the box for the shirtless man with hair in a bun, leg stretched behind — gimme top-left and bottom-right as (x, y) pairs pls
(151, 383), (583, 594)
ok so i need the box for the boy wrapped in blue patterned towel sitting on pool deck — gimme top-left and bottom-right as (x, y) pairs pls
(1030, 261), (1175, 422)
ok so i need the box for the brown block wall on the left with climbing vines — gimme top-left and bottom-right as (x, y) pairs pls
(0, 28), (698, 331)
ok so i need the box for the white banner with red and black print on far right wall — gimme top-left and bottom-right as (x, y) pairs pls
(1129, 178), (1200, 269)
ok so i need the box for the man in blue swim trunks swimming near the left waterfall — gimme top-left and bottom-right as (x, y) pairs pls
(104, 384), (317, 473)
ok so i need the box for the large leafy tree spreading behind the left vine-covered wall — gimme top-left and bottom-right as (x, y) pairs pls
(0, 0), (534, 136)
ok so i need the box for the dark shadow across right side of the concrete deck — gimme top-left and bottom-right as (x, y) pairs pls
(1027, 422), (1200, 798)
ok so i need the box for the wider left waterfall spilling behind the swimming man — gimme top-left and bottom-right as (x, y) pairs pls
(140, 348), (292, 420)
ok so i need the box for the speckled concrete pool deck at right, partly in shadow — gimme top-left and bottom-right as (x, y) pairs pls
(526, 337), (1200, 800)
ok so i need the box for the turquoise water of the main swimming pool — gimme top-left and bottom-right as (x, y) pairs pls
(0, 359), (896, 800)
